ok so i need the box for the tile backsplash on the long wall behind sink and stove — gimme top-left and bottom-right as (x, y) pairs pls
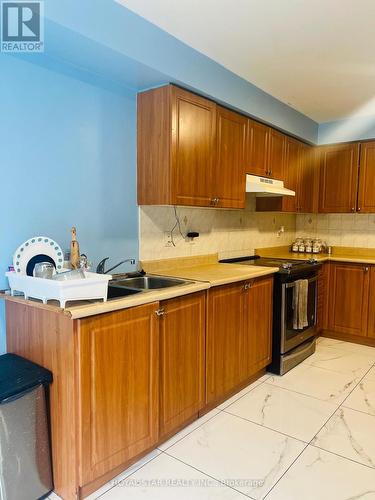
(139, 196), (296, 260)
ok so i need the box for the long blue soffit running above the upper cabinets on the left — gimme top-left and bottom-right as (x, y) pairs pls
(39, 0), (318, 142)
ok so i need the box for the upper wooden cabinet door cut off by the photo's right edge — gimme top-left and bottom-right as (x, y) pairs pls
(357, 141), (375, 212)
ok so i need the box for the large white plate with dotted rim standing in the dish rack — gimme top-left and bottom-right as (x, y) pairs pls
(13, 236), (64, 275)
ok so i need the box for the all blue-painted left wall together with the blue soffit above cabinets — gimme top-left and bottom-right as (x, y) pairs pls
(0, 0), (324, 351)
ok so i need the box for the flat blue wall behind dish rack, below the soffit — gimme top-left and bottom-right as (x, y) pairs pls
(0, 55), (138, 351)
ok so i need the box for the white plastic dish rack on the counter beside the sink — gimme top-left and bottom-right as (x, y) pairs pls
(5, 271), (112, 308)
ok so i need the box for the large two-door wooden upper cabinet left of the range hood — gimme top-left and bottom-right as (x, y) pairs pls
(137, 85), (247, 208)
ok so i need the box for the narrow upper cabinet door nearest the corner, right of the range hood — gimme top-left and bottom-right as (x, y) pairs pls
(297, 143), (319, 214)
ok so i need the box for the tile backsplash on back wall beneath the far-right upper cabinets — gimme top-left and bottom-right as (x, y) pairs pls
(296, 214), (375, 248)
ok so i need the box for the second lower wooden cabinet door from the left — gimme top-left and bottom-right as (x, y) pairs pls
(160, 292), (206, 437)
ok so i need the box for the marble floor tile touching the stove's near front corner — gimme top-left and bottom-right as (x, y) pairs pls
(267, 363), (359, 406)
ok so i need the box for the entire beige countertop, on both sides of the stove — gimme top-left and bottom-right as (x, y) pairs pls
(5, 247), (375, 319)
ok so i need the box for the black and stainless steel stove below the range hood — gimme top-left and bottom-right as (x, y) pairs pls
(220, 255), (321, 375)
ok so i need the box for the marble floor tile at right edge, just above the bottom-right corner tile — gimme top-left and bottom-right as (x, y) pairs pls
(311, 408), (375, 468)
